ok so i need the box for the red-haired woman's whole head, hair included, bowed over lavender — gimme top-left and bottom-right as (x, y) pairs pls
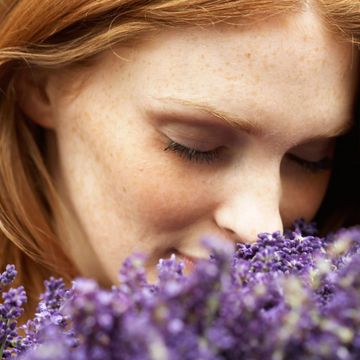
(0, 0), (360, 316)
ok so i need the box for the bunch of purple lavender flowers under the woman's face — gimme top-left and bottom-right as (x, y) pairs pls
(0, 221), (360, 360)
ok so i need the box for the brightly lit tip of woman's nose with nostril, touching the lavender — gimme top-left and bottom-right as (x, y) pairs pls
(214, 181), (283, 243)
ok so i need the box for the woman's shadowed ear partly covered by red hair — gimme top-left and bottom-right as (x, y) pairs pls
(15, 69), (54, 129)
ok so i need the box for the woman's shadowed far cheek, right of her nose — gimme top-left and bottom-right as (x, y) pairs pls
(280, 172), (330, 226)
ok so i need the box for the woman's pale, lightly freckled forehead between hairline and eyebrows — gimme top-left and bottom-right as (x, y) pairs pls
(102, 10), (358, 143)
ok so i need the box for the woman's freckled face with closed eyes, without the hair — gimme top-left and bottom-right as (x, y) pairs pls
(38, 7), (357, 282)
